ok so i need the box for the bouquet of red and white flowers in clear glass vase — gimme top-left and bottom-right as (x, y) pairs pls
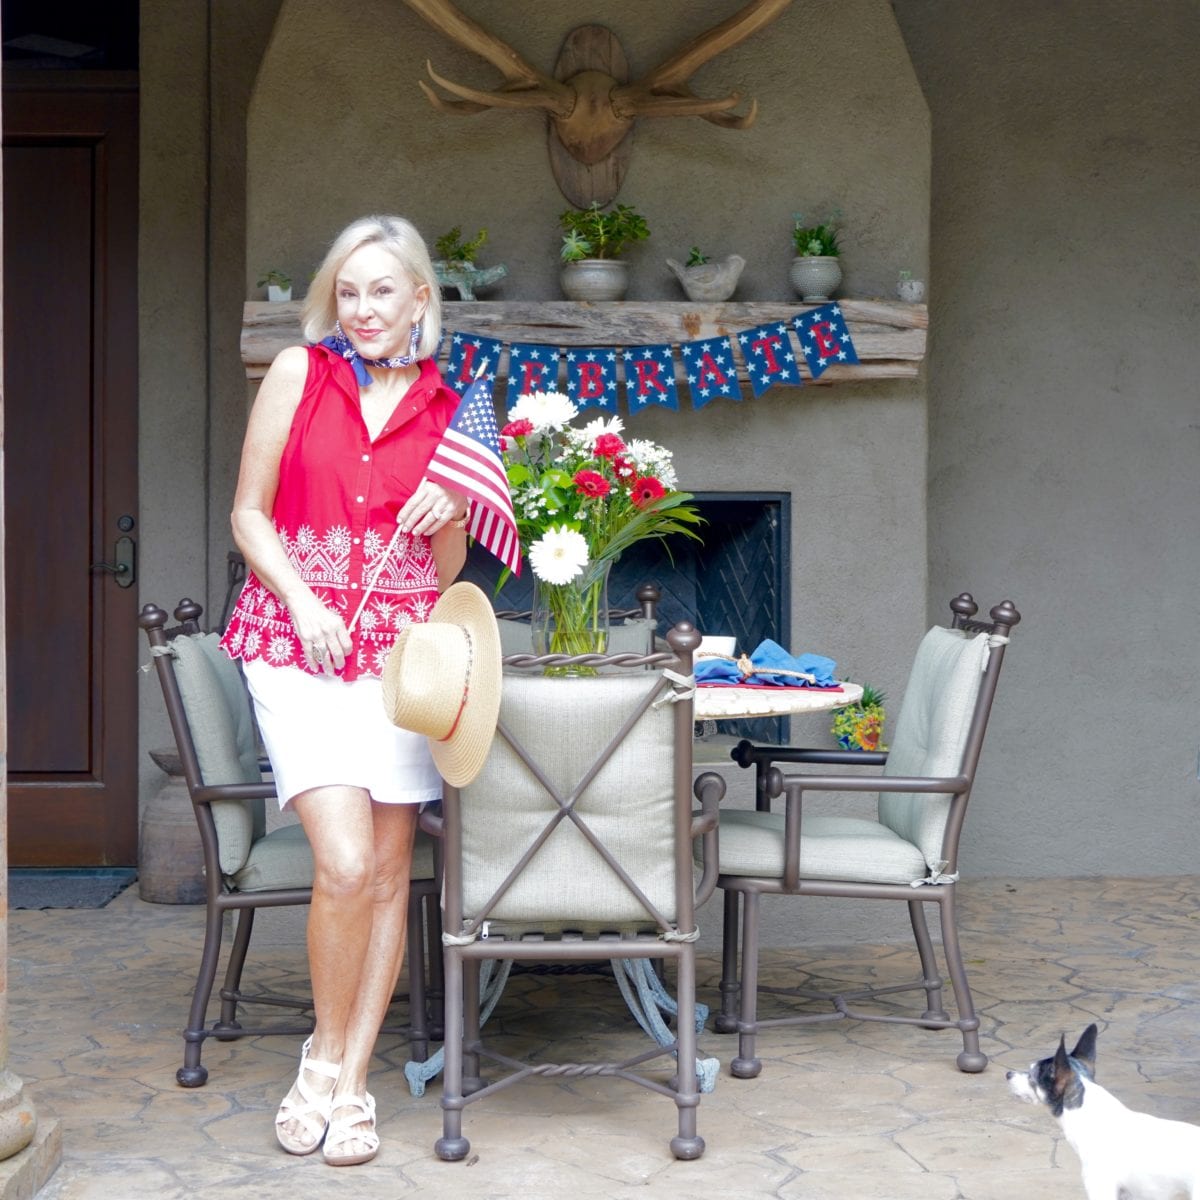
(500, 391), (702, 674)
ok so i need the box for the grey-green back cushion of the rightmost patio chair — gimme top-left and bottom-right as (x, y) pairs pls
(878, 625), (988, 868)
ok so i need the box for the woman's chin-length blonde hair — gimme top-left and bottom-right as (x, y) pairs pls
(300, 216), (442, 359)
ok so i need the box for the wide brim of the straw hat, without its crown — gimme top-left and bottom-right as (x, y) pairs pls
(430, 583), (503, 787)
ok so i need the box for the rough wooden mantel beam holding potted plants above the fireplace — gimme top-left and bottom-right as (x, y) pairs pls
(241, 300), (929, 384)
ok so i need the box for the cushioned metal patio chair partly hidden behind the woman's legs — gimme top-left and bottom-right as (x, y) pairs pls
(138, 600), (442, 1087)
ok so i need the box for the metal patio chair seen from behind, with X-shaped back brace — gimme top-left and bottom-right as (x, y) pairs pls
(422, 623), (724, 1160)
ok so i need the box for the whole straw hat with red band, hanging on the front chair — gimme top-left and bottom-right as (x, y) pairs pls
(383, 583), (500, 787)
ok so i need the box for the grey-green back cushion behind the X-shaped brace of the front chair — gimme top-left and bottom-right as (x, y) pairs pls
(461, 671), (676, 930)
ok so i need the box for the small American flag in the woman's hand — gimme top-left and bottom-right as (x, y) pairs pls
(425, 373), (521, 575)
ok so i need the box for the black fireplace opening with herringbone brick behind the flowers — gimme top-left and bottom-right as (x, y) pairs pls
(462, 492), (792, 744)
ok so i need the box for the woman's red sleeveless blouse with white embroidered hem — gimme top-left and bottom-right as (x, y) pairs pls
(221, 346), (458, 680)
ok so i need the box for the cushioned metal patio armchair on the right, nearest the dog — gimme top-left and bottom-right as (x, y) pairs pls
(716, 593), (1021, 1079)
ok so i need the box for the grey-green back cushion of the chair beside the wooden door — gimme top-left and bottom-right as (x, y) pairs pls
(170, 634), (265, 875)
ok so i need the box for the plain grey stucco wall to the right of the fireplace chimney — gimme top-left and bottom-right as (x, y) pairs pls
(895, 0), (1200, 876)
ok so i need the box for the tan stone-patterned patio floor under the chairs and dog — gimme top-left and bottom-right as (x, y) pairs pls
(8, 877), (1200, 1200)
